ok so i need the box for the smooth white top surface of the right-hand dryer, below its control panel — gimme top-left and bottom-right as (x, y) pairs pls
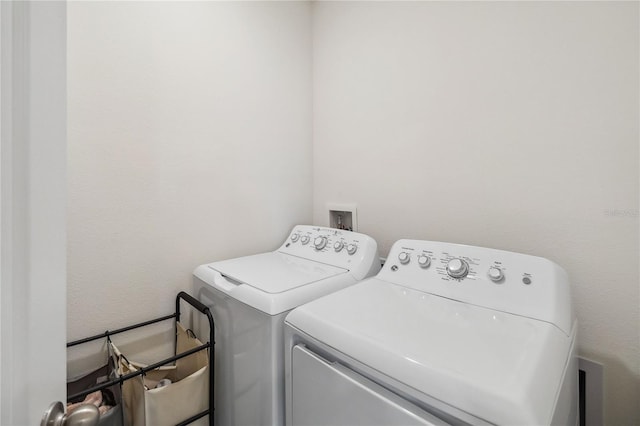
(286, 278), (571, 424)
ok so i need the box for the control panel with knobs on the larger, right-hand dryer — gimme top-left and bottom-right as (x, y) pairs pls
(377, 240), (574, 335)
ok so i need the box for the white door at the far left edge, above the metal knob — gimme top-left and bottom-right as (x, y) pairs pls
(0, 1), (67, 424)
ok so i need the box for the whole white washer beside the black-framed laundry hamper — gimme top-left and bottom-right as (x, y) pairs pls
(194, 225), (380, 426)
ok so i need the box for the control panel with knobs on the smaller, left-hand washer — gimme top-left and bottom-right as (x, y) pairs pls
(278, 225), (380, 280)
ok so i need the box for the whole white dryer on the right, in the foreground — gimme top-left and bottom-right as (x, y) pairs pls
(285, 240), (578, 426)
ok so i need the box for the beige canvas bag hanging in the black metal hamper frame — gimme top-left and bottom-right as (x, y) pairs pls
(109, 324), (209, 426)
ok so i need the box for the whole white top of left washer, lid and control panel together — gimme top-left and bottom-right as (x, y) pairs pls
(194, 225), (380, 315)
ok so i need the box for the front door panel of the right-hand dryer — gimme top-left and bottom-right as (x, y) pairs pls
(291, 345), (447, 426)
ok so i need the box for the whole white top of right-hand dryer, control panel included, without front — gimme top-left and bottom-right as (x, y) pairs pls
(286, 240), (575, 424)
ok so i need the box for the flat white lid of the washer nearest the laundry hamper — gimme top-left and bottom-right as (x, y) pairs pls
(194, 252), (355, 315)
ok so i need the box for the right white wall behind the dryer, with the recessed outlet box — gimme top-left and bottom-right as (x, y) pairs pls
(313, 2), (640, 425)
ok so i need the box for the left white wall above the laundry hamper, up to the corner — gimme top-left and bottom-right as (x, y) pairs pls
(68, 2), (312, 346)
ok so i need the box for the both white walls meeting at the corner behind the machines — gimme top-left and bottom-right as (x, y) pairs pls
(68, 2), (640, 424)
